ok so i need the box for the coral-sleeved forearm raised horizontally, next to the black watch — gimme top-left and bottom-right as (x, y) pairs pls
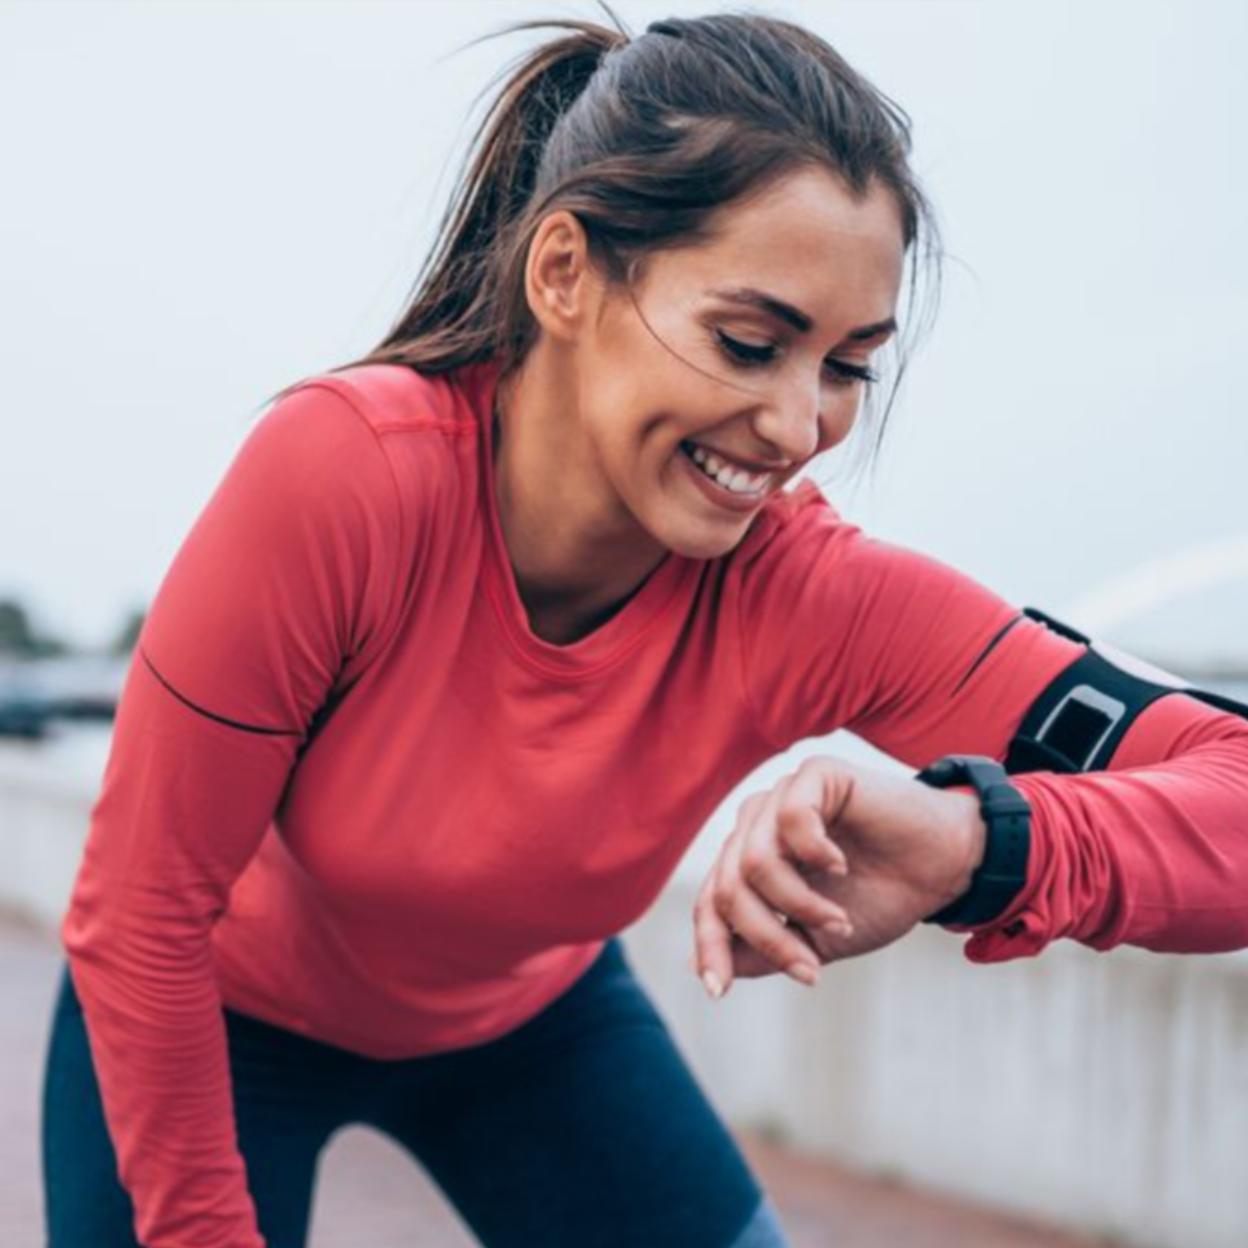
(948, 698), (1248, 962)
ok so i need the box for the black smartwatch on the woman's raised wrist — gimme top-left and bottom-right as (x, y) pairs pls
(915, 754), (1031, 925)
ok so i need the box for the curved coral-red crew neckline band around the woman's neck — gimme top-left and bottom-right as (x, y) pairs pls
(459, 359), (705, 679)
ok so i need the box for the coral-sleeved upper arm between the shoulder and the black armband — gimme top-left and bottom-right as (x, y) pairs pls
(741, 502), (1083, 768)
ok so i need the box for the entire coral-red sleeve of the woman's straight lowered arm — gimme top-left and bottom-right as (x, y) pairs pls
(60, 382), (399, 1248)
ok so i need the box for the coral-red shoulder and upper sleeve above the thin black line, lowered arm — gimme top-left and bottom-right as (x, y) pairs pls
(137, 383), (401, 734)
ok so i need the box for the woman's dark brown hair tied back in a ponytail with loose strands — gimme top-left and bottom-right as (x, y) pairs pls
(294, 0), (940, 476)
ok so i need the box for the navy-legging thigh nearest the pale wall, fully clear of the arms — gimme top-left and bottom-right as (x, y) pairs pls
(378, 940), (785, 1248)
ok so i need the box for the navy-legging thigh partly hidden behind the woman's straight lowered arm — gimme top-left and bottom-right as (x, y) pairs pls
(41, 963), (334, 1248)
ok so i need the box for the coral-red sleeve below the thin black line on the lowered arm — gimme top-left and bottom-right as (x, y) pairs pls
(60, 661), (283, 1248)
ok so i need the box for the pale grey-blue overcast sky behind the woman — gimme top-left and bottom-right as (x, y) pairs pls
(0, 0), (1248, 658)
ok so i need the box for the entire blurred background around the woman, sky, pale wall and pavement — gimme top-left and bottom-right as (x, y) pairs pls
(0, 0), (1248, 1248)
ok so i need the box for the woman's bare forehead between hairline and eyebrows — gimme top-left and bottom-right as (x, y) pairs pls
(648, 168), (905, 327)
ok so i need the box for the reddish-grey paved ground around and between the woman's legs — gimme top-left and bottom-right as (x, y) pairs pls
(0, 915), (1122, 1248)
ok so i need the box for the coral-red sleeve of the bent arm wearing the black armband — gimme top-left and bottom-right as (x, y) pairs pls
(740, 486), (1248, 962)
